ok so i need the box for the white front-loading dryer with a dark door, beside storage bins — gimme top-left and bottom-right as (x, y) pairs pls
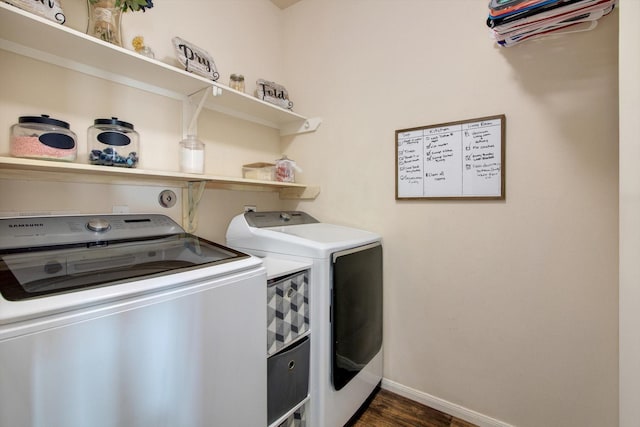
(226, 211), (382, 427)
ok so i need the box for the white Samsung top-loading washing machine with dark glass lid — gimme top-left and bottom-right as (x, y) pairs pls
(0, 215), (267, 427)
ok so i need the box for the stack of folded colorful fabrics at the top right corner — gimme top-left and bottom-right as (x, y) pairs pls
(487, 0), (617, 47)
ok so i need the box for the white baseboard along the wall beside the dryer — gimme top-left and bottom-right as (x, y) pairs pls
(382, 378), (514, 427)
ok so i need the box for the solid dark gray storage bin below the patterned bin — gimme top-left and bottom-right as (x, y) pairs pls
(267, 337), (310, 424)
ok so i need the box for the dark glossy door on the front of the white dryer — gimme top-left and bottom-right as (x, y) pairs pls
(331, 243), (382, 390)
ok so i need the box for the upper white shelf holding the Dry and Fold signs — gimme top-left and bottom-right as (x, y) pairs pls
(0, 2), (321, 135)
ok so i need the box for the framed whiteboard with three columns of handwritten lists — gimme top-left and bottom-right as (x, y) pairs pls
(396, 114), (506, 200)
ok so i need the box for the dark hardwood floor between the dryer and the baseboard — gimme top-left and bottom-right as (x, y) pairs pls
(351, 389), (477, 427)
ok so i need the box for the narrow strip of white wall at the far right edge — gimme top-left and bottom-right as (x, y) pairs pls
(620, 0), (640, 427)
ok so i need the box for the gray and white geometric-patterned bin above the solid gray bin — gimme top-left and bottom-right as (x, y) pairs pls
(267, 270), (309, 356)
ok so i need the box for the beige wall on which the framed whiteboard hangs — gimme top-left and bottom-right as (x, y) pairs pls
(284, 0), (618, 427)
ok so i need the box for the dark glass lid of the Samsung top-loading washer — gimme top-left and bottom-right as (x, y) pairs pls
(0, 233), (249, 301)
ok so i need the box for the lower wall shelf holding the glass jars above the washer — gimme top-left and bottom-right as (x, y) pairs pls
(0, 157), (320, 199)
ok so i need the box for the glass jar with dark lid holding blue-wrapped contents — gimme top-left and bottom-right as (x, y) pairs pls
(87, 117), (140, 168)
